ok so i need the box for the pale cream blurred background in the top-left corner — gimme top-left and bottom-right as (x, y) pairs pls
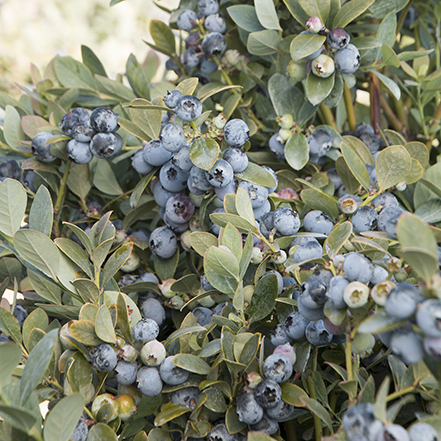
(0, 0), (175, 95)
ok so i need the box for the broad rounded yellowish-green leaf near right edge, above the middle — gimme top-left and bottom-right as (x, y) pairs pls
(375, 145), (411, 191)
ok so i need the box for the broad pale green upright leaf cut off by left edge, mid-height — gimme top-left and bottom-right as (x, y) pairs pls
(0, 179), (27, 237)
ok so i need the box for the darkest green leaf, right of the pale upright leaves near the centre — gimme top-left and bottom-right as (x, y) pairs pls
(248, 274), (279, 324)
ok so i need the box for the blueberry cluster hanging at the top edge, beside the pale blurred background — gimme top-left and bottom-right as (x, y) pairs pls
(166, 0), (227, 77)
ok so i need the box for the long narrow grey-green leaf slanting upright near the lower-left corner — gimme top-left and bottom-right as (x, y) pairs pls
(20, 329), (58, 406)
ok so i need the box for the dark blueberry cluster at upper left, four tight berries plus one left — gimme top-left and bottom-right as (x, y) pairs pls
(32, 107), (123, 164)
